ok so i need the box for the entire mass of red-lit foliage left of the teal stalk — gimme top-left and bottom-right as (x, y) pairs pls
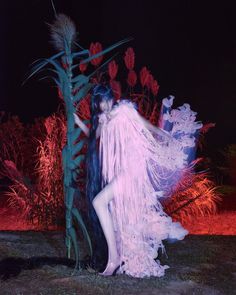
(0, 112), (66, 229)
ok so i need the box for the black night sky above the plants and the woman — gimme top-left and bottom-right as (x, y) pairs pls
(0, 0), (236, 147)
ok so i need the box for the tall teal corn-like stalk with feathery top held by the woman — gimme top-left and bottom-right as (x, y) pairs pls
(28, 14), (129, 269)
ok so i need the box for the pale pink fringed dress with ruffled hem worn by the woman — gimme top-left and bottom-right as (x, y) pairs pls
(99, 99), (202, 278)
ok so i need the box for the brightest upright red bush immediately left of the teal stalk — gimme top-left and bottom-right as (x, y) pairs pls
(33, 113), (66, 226)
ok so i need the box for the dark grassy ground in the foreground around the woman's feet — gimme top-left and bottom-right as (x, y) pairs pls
(0, 231), (236, 295)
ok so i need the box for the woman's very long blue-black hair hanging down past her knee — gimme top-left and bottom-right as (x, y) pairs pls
(86, 84), (113, 241)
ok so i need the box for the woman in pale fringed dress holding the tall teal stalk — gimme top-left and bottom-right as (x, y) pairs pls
(74, 85), (201, 277)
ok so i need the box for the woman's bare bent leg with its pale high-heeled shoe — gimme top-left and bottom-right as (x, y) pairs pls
(93, 179), (120, 275)
